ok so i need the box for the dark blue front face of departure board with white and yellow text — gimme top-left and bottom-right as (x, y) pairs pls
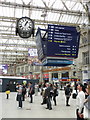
(47, 24), (80, 58)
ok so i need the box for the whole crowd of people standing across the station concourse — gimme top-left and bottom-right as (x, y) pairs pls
(6, 82), (90, 120)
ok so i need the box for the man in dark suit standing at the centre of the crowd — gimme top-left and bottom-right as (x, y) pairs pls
(44, 83), (52, 110)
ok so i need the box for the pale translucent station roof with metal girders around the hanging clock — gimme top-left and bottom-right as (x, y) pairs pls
(0, 0), (88, 63)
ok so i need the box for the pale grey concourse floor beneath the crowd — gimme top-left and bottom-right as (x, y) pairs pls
(0, 91), (76, 118)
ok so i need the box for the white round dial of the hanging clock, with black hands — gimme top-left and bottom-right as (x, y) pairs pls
(18, 17), (33, 31)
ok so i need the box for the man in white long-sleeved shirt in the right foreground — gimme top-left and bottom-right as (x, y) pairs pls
(76, 83), (85, 120)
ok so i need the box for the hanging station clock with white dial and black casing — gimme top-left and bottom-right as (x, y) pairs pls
(17, 17), (34, 38)
